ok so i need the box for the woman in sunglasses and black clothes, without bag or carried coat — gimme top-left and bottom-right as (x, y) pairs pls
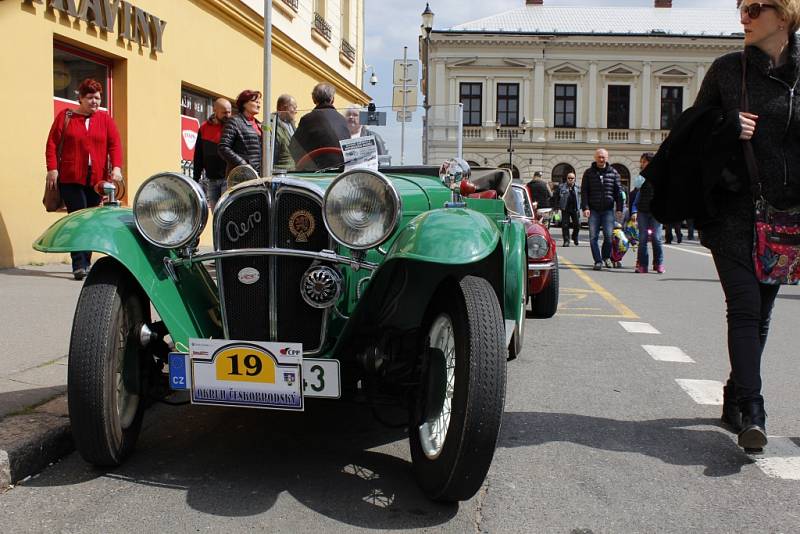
(695, 0), (800, 452)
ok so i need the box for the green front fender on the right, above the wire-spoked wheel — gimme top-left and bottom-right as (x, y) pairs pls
(333, 209), (526, 356)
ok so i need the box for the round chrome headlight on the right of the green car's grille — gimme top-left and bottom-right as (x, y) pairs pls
(322, 169), (402, 250)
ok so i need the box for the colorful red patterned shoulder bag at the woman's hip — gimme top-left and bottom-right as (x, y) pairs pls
(753, 199), (800, 285)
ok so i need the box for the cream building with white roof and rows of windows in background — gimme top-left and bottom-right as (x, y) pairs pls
(420, 0), (743, 188)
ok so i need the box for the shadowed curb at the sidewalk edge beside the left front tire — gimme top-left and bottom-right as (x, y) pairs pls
(0, 395), (74, 491)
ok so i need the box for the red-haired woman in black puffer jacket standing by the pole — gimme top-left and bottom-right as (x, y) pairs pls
(217, 89), (262, 176)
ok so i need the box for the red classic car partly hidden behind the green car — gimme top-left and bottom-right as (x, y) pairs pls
(506, 183), (558, 318)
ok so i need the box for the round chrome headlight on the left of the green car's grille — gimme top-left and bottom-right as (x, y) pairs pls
(133, 172), (208, 248)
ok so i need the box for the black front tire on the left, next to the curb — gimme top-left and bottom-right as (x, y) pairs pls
(67, 258), (150, 467)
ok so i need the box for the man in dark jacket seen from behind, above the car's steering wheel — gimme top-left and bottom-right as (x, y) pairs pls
(290, 83), (350, 170)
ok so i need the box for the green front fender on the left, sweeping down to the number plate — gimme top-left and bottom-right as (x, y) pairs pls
(33, 207), (222, 351)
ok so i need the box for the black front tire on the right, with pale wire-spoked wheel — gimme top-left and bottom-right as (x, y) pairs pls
(409, 276), (507, 501)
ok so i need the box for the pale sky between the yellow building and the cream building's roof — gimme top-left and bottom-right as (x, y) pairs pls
(364, 0), (736, 163)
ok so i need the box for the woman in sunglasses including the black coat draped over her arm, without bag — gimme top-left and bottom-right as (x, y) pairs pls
(645, 0), (800, 452)
